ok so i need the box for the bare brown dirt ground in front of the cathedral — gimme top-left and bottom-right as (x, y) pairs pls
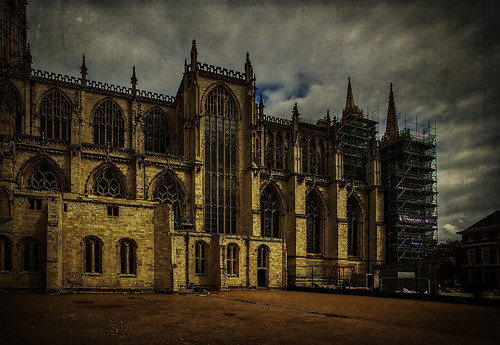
(0, 290), (500, 345)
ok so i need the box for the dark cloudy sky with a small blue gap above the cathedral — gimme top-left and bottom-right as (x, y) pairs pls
(28, 0), (500, 241)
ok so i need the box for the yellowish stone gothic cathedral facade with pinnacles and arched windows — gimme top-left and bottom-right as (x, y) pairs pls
(0, 0), (385, 291)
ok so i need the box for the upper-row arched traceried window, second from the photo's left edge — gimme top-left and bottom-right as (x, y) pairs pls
(40, 90), (72, 141)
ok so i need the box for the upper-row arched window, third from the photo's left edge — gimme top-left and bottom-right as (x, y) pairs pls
(94, 99), (125, 147)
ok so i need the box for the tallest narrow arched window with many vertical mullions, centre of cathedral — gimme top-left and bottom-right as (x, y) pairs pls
(205, 86), (236, 234)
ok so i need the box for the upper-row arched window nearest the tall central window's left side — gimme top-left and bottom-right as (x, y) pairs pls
(144, 108), (172, 153)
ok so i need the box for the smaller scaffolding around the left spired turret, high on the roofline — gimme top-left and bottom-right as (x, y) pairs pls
(338, 114), (378, 181)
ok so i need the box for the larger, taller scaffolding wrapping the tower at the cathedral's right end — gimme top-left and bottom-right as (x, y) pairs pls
(381, 118), (437, 263)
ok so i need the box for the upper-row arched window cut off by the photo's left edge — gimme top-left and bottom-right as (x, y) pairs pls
(0, 81), (23, 135)
